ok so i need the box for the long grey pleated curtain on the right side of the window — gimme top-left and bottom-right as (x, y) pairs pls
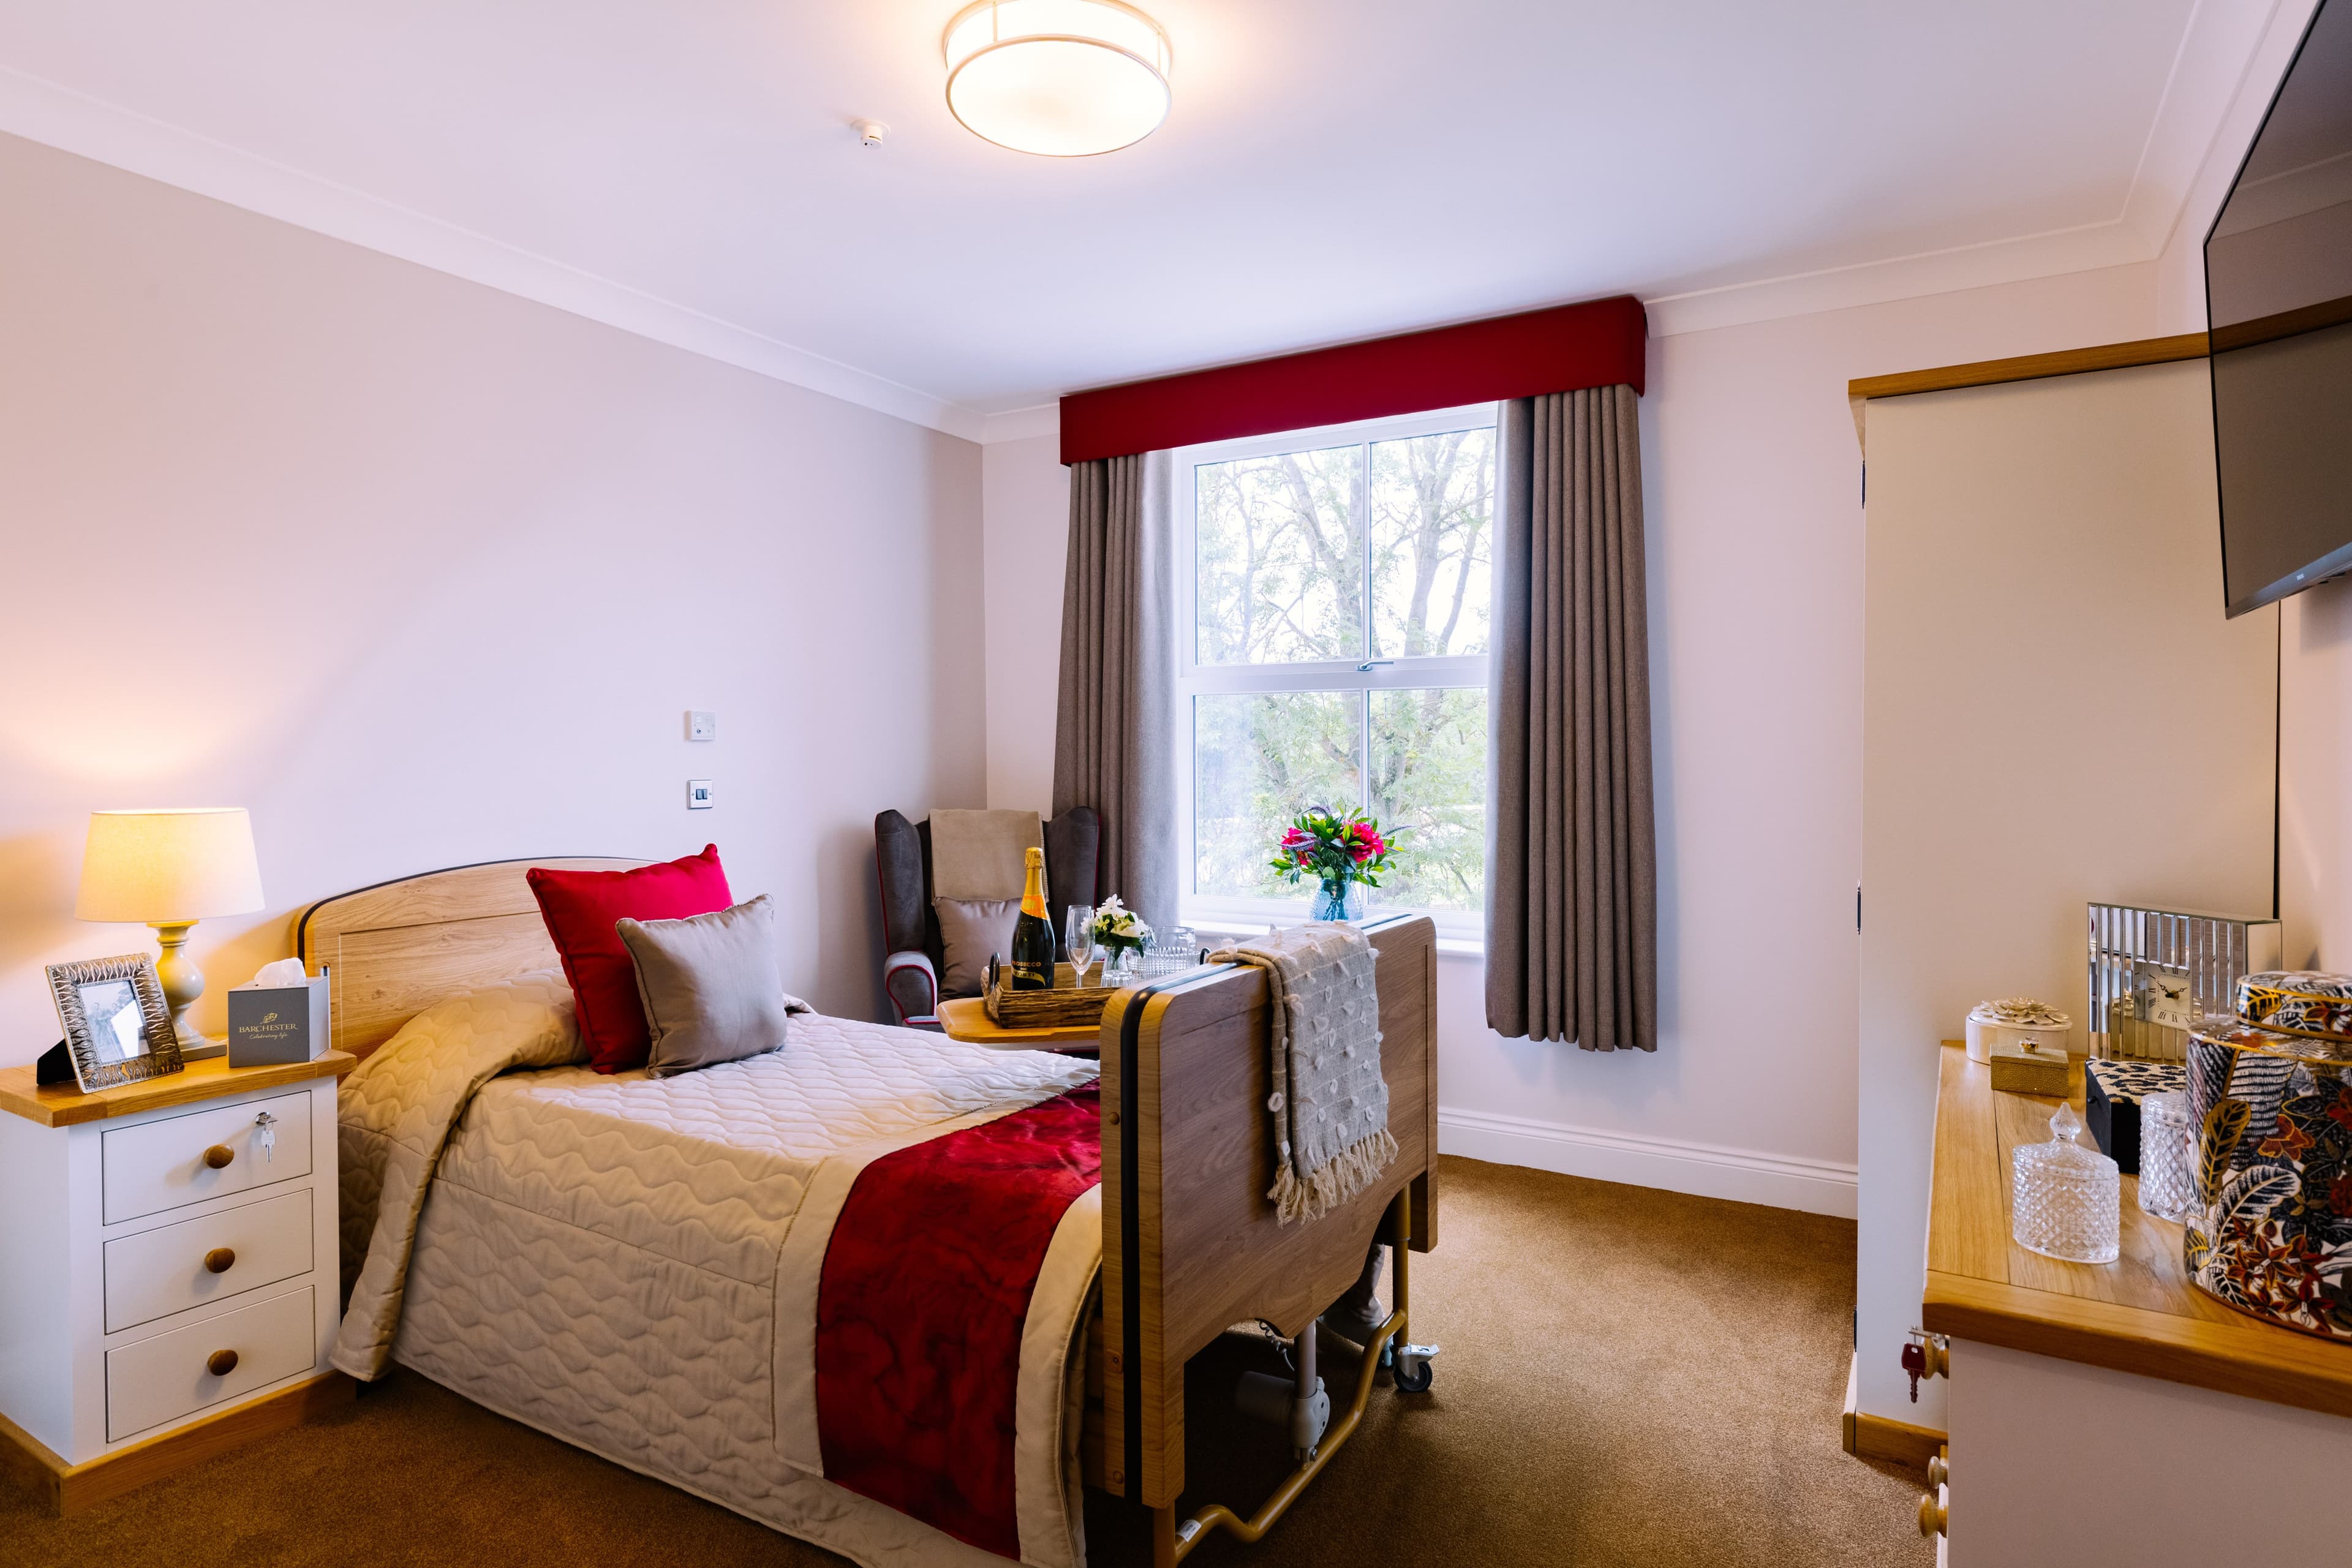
(1487, 385), (1658, 1051)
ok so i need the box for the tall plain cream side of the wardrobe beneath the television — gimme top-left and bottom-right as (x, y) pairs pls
(1858, 360), (2279, 1427)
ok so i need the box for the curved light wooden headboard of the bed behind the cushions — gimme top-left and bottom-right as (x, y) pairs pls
(294, 856), (644, 1055)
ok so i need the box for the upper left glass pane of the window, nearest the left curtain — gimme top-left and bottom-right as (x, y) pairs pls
(1193, 447), (1364, 665)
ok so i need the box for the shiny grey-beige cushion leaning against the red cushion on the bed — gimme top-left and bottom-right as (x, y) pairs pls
(614, 893), (786, 1077)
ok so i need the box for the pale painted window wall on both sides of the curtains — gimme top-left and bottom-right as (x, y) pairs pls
(988, 266), (2157, 1215)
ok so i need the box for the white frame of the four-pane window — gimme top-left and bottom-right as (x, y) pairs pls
(1169, 402), (1503, 945)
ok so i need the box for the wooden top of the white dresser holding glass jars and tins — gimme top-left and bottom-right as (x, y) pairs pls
(1919, 1039), (2352, 1415)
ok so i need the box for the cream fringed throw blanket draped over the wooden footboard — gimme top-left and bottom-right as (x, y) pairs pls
(1209, 924), (1397, 1225)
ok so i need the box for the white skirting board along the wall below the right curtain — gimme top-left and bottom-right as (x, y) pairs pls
(1437, 1105), (1856, 1220)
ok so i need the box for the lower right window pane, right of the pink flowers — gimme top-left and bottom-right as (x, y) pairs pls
(1371, 687), (1487, 910)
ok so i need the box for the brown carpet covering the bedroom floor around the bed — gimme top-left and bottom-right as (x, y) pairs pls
(0, 1159), (1933, 1568)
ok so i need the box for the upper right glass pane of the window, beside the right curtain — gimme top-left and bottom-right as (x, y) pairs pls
(1371, 428), (1493, 658)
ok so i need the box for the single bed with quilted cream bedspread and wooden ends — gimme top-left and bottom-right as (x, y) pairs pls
(299, 861), (1434, 1568)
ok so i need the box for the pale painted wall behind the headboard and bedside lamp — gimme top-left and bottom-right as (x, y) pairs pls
(0, 137), (986, 1063)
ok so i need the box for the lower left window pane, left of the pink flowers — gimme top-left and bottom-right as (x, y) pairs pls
(1193, 691), (1364, 898)
